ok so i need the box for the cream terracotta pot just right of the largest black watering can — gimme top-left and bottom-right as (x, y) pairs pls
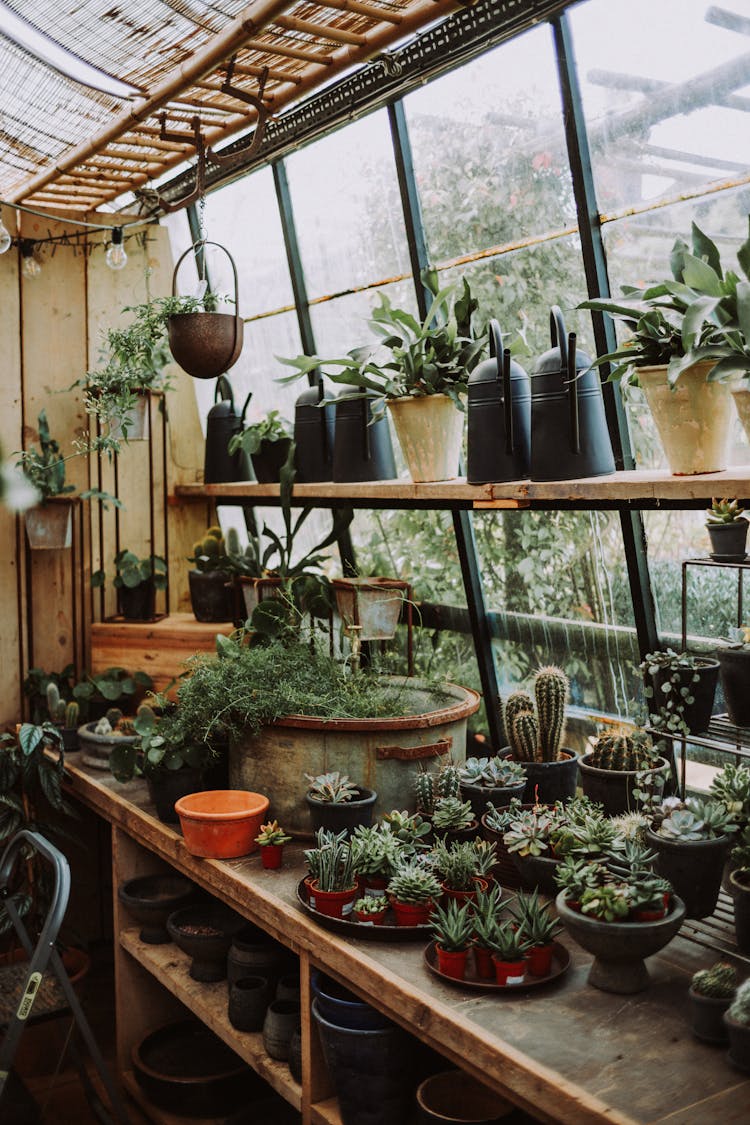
(638, 360), (733, 476)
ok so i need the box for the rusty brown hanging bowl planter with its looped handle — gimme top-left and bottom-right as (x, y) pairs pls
(168, 240), (244, 379)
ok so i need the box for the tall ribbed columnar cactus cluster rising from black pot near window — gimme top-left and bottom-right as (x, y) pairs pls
(504, 666), (569, 762)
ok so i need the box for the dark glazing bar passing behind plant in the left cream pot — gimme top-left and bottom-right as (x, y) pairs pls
(388, 101), (504, 750)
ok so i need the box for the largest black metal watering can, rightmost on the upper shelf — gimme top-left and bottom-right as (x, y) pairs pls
(531, 305), (615, 480)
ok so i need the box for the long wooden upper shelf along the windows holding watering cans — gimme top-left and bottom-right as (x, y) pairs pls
(174, 466), (750, 510)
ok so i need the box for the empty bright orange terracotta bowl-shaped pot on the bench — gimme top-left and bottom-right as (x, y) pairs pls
(174, 789), (269, 860)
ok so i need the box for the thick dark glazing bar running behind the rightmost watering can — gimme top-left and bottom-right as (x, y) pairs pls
(551, 12), (659, 656)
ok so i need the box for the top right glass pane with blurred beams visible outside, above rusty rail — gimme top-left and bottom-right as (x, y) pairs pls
(570, 0), (750, 213)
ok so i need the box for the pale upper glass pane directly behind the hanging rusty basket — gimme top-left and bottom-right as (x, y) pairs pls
(206, 168), (295, 316)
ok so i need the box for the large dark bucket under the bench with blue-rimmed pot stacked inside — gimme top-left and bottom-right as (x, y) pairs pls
(313, 999), (414, 1125)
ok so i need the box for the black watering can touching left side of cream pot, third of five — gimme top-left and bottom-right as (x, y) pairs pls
(333, 387), (396, 484)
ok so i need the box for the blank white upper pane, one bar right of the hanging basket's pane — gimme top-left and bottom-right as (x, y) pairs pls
(287, 110), (410, 297)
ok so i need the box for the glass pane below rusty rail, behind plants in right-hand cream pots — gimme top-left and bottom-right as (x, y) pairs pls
(603, 186), (750, 469)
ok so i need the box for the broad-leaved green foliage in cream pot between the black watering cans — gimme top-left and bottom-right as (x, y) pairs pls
(278, 270), (485, 417)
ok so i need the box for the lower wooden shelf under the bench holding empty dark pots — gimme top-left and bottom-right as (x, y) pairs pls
(119, 929), (301, 1109)
